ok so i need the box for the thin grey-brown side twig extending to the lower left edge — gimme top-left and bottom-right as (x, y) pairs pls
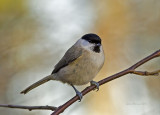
(0, 104), (57, 111)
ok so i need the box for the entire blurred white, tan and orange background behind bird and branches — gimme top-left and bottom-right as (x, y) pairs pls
(0, 0), (160, 115)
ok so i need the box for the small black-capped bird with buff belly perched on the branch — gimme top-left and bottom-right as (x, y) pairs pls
(21, 33), (105, 101)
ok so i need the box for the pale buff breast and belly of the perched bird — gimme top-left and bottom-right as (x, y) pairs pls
(55, 49), (104, 85)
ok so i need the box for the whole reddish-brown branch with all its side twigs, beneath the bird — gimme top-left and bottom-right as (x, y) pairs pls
(0, 50), (160, 115)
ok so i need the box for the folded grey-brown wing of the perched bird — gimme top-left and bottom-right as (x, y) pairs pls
(52, 46), (82, 74)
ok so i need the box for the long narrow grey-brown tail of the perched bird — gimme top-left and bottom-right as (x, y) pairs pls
(21, 74), (53, 94)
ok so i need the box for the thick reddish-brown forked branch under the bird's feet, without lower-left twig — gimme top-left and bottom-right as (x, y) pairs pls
(51, 49), (160, 115)
